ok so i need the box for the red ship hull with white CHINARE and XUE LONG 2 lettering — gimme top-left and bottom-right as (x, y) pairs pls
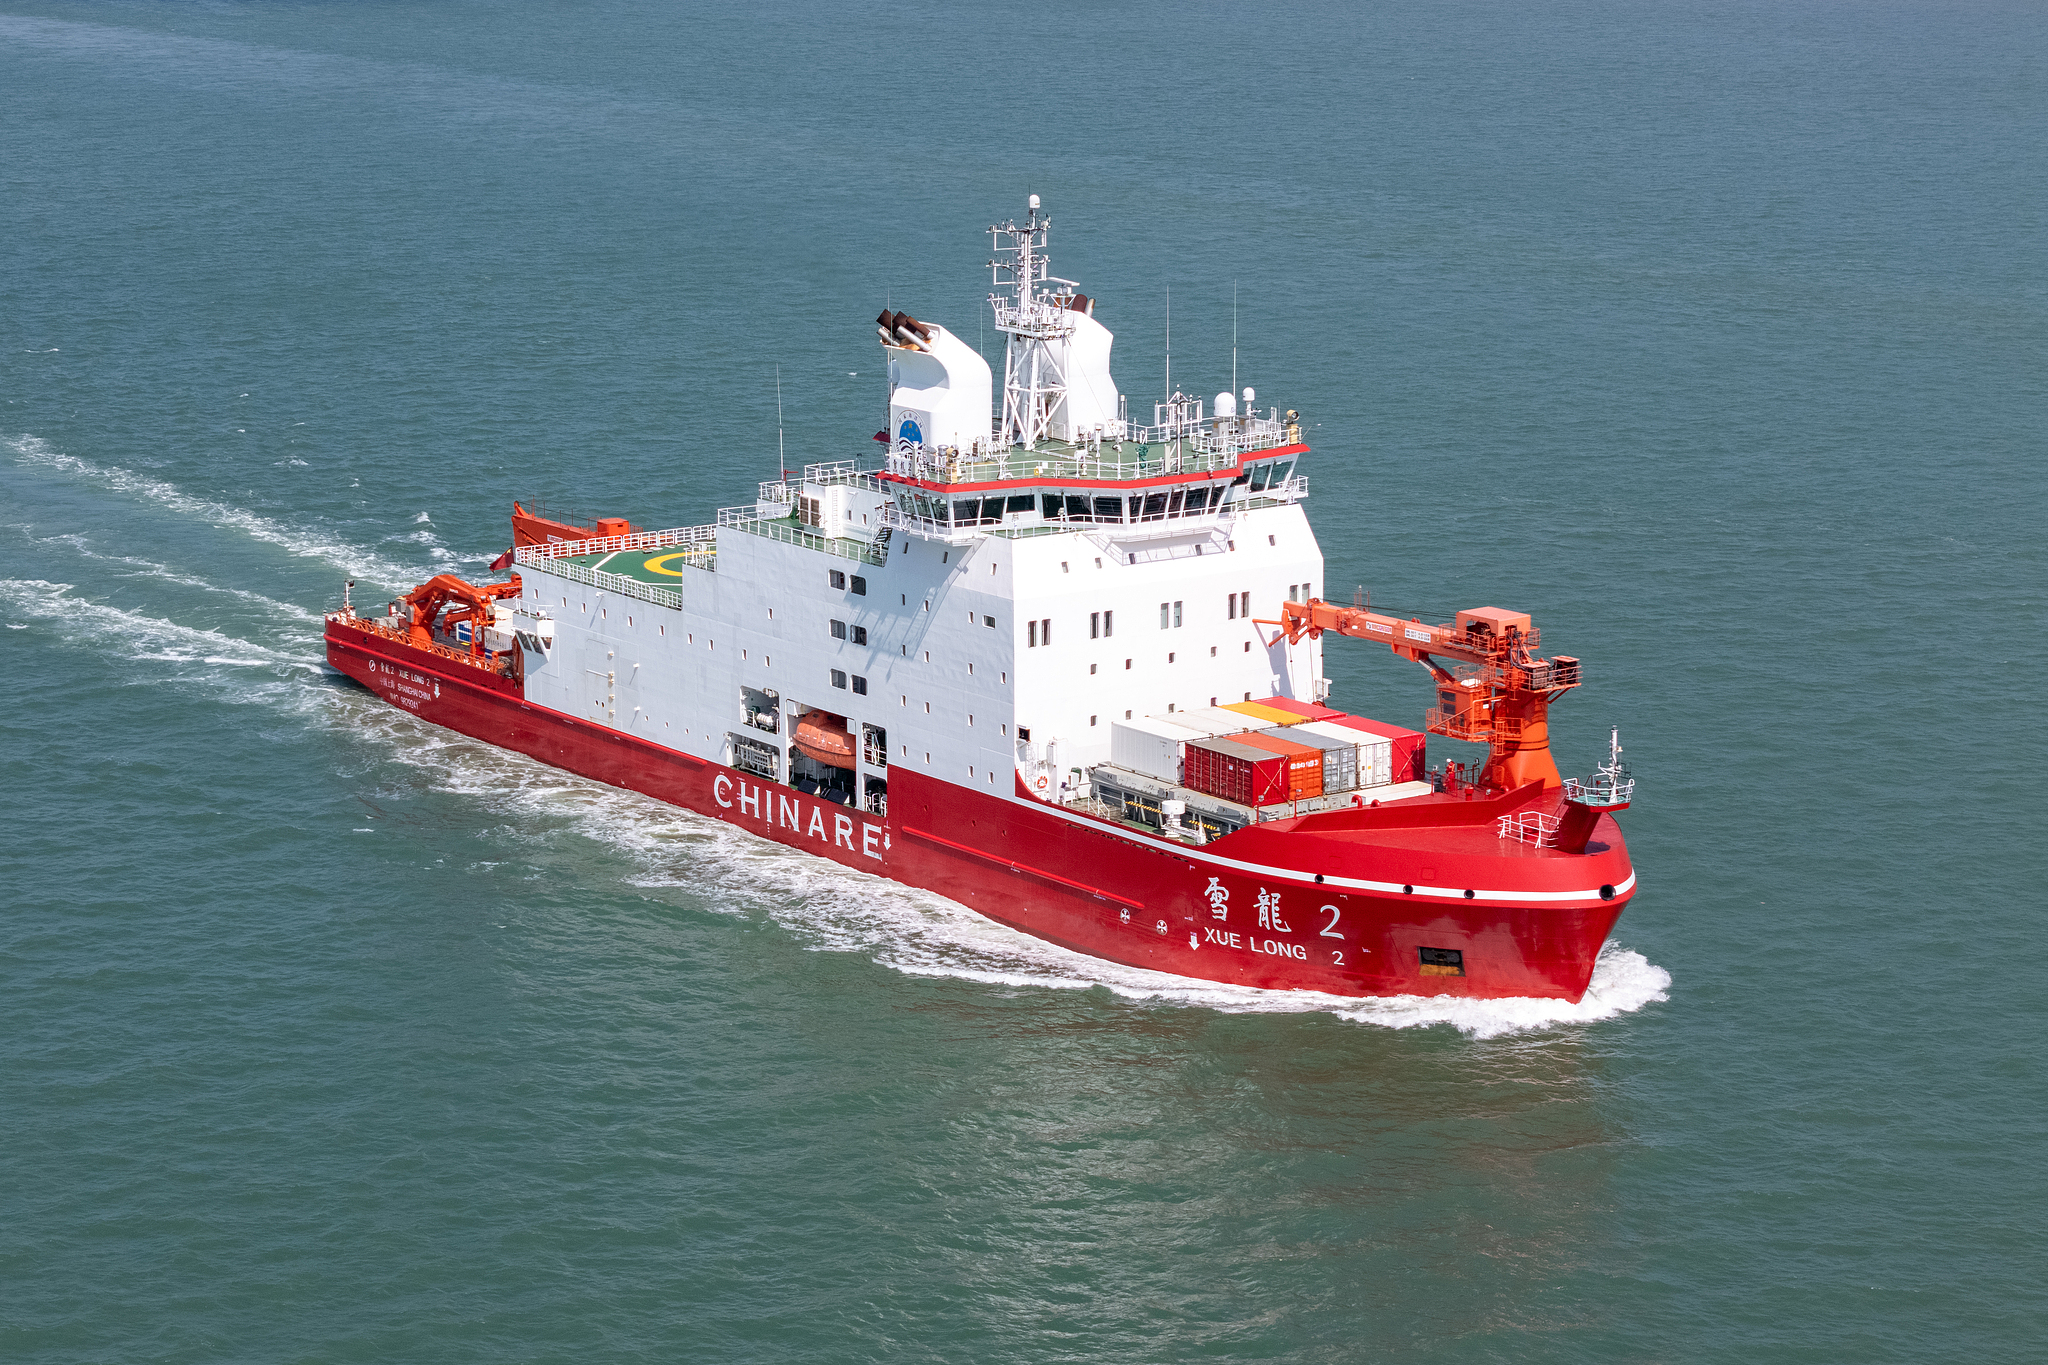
(326, 616), (1634, 1001)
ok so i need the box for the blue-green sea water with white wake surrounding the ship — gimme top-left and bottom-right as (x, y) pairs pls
(0, 0), (2048, 1363)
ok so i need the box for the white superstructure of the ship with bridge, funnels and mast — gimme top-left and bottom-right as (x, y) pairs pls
(514, 201), (1325, 810)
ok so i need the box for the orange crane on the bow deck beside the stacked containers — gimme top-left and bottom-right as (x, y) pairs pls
(1266, 600), (1579, 792)
